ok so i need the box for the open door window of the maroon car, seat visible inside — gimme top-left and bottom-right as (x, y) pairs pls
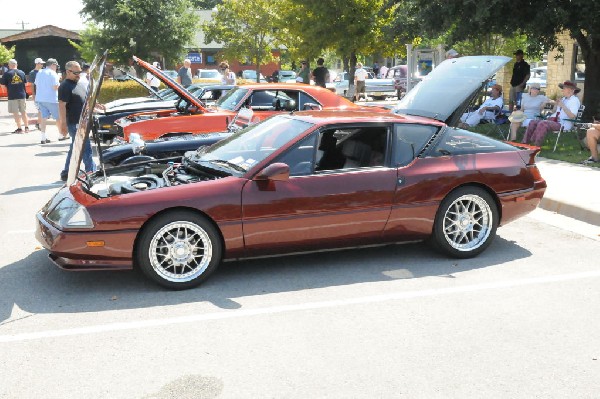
(315, 126), (388, 171)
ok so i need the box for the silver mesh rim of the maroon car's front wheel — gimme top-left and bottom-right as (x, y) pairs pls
(148, 221), (213, 283)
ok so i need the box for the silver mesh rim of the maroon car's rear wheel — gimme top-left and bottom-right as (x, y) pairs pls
(442, 194), (494, 252)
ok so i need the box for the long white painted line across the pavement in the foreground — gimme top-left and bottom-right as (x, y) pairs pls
(0, 270), (600, 343)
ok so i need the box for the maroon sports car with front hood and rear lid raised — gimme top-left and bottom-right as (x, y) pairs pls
(36, 56), (546, 289)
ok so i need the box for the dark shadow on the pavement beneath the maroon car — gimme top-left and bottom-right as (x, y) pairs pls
(0, 237), (531, 328)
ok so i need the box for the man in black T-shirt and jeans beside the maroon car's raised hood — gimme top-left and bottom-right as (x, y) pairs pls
(58, 61), (96, 181)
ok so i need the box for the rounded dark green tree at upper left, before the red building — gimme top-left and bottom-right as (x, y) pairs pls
(81, 0), (198, 64)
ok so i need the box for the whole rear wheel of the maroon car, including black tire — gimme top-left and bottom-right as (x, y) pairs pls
(431, 187), (498, 258)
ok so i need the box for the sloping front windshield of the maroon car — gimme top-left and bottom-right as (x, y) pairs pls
(199, 115), (313, 172)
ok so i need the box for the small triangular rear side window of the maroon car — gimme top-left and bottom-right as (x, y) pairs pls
(394, 123), (439, 166)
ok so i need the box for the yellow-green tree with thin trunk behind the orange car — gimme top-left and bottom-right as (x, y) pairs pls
(202, 0), (285, 82)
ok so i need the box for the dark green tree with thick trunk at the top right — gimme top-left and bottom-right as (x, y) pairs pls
(394, 0), (600, 119)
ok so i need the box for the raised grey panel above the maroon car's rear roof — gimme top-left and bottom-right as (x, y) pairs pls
(394, 55), (511, 126)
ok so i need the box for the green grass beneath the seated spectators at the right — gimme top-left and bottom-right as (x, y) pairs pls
(469, 123), (600, 168)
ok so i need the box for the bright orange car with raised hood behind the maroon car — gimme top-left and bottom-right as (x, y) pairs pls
(115, 58), (359, 141)
